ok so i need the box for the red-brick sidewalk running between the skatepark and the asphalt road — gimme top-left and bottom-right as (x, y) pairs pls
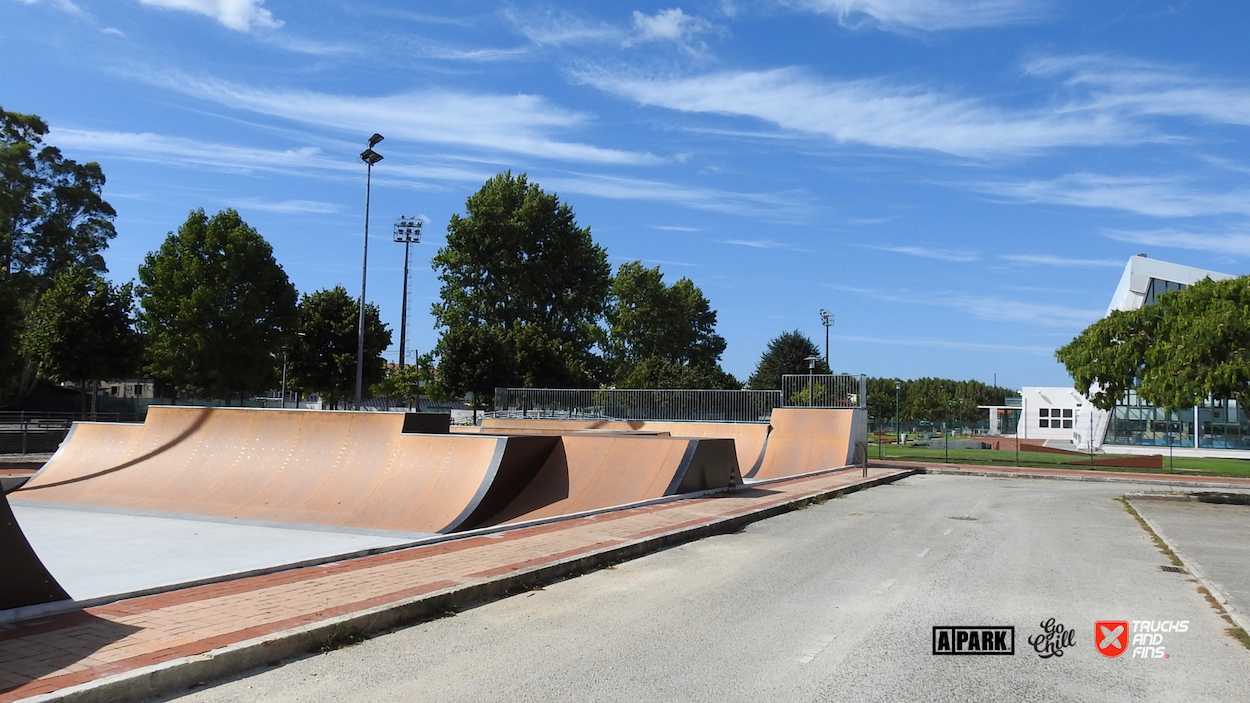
(0, 468), (913, 703)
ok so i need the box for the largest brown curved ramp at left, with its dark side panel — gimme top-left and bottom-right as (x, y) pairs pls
(11, 407), (558, 533)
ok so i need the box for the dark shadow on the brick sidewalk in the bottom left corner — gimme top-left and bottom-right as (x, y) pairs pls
(0, 610), (143, 695)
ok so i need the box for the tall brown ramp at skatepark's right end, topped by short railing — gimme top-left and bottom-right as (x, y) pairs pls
(746, 408), (861, 479)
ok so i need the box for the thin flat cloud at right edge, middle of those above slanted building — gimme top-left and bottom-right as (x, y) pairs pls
(970, 173), (1250, 218)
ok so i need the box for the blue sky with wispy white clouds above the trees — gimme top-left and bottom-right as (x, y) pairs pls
(0, 0), (1250, 387)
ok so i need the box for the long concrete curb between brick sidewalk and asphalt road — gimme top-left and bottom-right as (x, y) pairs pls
(21, 468), (920, 703)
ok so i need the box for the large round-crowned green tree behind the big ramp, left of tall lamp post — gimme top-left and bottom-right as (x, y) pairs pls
(139, 209), (295, 399)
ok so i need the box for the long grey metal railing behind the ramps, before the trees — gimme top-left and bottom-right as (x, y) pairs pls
(486, 388), (781, 423)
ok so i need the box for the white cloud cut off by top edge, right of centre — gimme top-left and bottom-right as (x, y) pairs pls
(779, 0), (1049, 31)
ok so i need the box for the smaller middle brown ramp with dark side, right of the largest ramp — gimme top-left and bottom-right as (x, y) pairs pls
(484, 434), (741, 525)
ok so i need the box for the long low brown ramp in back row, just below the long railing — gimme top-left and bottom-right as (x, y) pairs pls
(481, 418), (769, 474)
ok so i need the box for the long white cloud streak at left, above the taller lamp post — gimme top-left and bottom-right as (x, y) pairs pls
(145, 74), (661, 164)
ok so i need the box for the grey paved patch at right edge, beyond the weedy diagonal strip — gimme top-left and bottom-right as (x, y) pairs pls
(1133, 499), (1250, 630)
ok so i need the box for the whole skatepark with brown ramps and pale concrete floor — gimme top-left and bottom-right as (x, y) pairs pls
(0, 395), (863, 622)
